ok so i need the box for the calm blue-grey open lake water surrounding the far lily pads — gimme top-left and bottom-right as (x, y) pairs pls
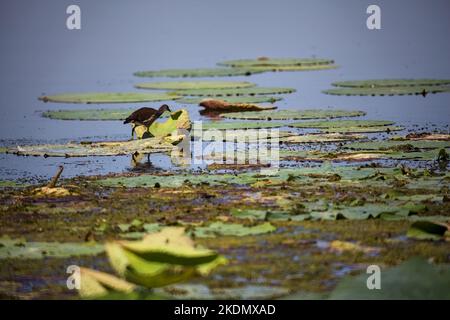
(0, 0), (450, 179)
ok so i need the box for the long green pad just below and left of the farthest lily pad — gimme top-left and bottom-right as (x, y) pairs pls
(134, 68), (263, 78)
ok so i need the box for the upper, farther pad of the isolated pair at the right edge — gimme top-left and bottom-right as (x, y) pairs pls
(332, 79), (450, 88)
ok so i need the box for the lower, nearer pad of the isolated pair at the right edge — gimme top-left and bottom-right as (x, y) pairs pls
(322, 86), (450, 96)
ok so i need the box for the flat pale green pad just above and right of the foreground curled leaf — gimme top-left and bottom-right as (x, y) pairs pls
(193, 221), (276, 238)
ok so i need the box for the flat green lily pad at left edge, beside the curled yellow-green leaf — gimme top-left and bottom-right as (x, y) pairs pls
(0, 238), (104, 259)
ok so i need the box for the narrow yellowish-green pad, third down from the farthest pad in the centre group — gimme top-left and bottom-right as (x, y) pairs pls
(135, 81), (256, 90)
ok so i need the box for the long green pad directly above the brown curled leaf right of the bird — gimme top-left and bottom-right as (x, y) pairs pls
(173, 87), (295, 97)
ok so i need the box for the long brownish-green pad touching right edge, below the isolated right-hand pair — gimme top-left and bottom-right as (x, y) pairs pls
(344, 140), (450, 151)
